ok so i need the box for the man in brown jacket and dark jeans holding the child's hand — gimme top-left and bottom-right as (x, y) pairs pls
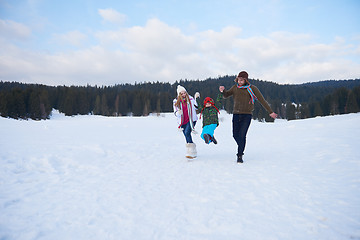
(219, 71), (277, 163)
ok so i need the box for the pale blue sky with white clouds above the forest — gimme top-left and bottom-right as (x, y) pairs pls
(0, 0), (360, 85)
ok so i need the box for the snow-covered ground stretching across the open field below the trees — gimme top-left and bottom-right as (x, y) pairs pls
(0, 112), (360, 240)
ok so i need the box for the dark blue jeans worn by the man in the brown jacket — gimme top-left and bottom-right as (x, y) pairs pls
(233, 114), (252, 156)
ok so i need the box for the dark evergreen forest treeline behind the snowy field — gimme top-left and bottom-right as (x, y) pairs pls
(0, 76), (360, 121)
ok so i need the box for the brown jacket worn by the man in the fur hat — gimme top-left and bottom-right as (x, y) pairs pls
(222, 84), (273, 114)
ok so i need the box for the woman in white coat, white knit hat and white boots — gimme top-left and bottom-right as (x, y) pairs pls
(173, 85), (198, 158)
